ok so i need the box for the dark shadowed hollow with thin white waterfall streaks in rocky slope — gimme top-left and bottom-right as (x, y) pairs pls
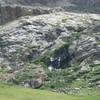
(49, 45), (71, 69)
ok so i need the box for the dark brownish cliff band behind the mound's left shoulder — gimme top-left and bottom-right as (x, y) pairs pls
(0, 5), (57, 24)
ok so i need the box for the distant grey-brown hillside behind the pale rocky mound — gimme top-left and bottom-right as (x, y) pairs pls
(0, 0), (100, 24)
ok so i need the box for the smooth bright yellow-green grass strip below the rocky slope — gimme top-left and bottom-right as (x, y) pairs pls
(0, 85), (100, 100)
